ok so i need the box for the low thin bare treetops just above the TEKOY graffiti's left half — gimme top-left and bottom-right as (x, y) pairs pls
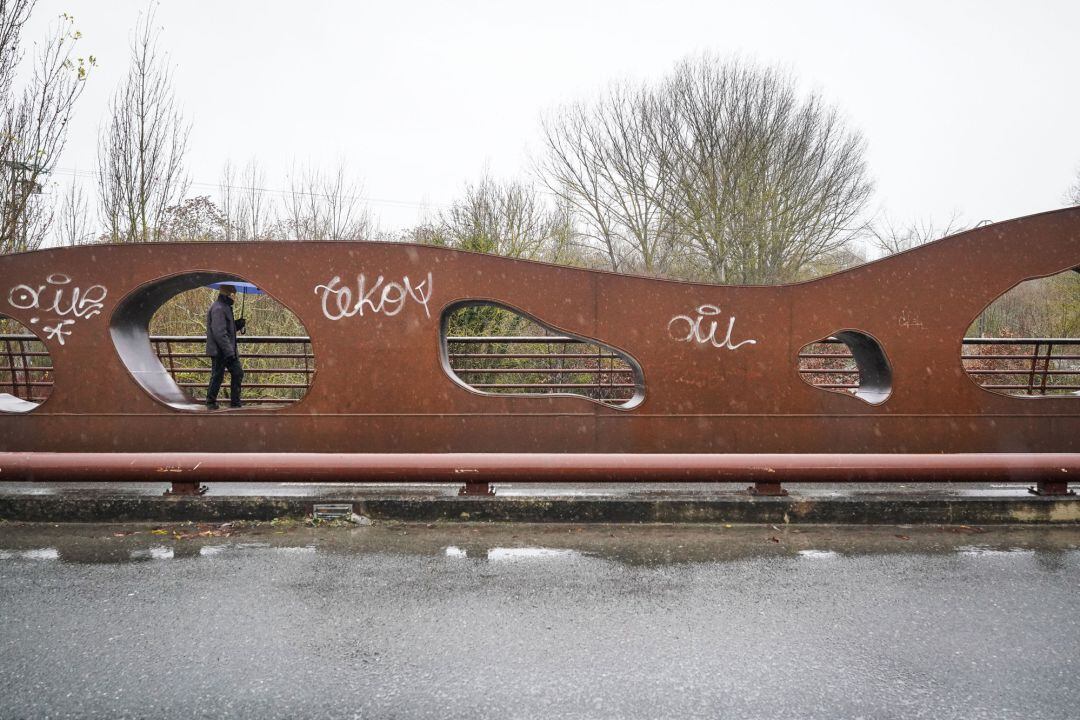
(279, 162), (375, 241)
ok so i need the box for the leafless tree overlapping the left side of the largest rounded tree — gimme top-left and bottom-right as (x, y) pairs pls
(538, 84), (675, 274)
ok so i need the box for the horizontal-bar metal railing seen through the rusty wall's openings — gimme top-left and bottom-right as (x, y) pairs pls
(0, 334), (1080, 404)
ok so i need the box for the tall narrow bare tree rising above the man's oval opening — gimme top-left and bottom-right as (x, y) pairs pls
(98, 12), (190, 243)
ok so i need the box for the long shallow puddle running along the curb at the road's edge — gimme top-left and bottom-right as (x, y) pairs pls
(0, 522), (1080, 567)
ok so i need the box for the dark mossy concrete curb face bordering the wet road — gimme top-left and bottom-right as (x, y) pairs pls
(0, 493), (1080, 525)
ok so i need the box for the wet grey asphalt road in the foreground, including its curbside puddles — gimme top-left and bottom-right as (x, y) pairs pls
(0, 524), (1080, 720)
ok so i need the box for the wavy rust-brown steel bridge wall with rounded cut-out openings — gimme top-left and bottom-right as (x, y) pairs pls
(0, 208), (1080, 453)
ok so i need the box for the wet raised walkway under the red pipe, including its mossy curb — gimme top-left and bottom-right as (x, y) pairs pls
(0, 483), (1080, 525)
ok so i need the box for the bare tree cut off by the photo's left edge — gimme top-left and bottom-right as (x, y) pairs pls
(0, 0), (95, 253)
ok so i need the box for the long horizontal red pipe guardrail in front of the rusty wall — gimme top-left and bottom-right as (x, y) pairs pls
(0, 452), (1080, 484)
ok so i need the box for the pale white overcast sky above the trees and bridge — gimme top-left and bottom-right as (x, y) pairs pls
(25, 0), (1080, 240)
